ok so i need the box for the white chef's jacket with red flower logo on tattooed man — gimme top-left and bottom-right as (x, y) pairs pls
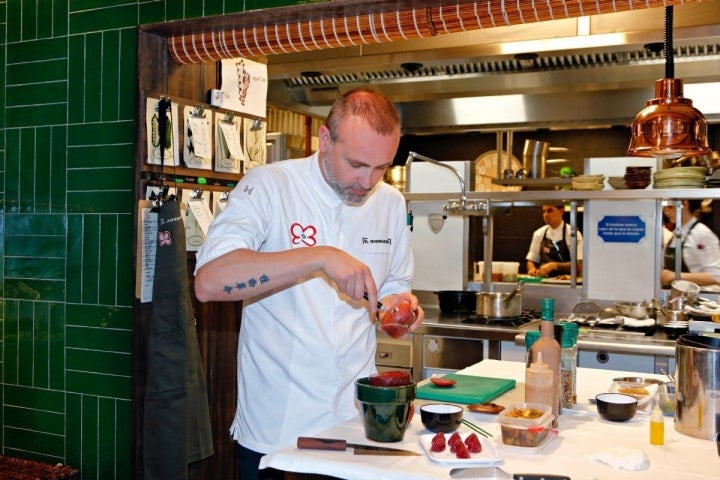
(197, 153), (413, 453)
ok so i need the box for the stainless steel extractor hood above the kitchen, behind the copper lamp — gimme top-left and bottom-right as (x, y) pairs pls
(268, 25), (720, 134)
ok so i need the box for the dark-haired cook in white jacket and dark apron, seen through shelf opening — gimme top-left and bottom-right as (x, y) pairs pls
(525, 205), (583, 277)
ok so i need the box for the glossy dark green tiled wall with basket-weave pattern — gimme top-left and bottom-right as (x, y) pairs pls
(0, 0), (312, 480)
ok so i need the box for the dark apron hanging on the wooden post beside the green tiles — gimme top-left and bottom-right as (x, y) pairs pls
(143, 201), (213, 480)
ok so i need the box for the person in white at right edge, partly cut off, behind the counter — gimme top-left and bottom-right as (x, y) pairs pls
(660, 200), (720, 286)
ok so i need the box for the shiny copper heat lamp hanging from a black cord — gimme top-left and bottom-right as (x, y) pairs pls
(627, 6), (710, 159)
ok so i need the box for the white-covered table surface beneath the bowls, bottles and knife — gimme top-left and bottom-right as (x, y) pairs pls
(261, 360), (720, 480)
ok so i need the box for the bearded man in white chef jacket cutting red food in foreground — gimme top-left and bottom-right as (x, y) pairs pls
(195, 90), (424, 480)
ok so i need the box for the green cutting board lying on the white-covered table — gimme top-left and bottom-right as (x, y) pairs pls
(415, 373), (515, 403)
